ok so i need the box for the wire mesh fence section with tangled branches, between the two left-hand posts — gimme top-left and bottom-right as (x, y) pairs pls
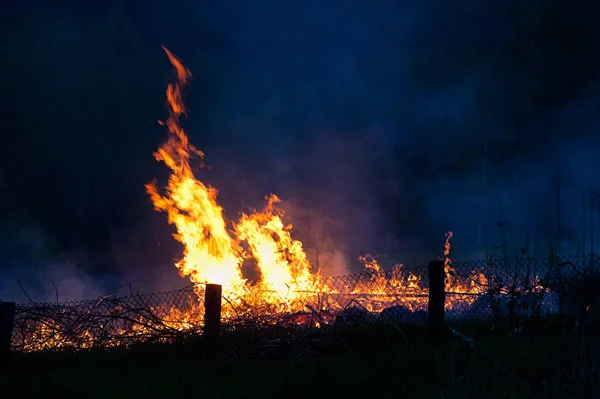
(11, 287), (202, 352)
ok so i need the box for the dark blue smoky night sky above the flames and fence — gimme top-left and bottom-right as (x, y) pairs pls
(0, 0), (600, 297)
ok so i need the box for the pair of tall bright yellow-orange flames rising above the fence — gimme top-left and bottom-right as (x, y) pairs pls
(146, 47), (320, 310)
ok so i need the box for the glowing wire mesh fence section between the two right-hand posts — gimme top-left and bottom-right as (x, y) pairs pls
(223, 266), (428, 336)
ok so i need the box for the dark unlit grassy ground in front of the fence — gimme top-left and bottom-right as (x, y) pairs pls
(0, 318), (600, 399)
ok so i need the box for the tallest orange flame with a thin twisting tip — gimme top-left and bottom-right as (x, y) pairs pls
(146, 47), (244, 289)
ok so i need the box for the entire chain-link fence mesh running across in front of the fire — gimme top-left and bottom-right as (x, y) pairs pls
(12, 256), (600, 351)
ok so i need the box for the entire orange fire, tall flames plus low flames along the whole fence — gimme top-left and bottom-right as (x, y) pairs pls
(11, 47), (532, 351)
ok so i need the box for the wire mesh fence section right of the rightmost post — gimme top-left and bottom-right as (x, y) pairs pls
(446, 256), (600, 322)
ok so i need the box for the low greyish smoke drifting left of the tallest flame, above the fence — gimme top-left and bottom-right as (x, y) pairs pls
(0, 226), (190, 303)
